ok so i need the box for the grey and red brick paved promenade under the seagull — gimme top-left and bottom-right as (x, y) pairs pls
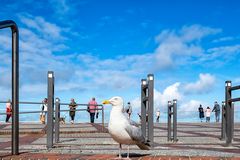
(0, 123), (240, 160)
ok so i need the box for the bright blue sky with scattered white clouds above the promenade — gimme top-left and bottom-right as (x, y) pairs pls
(0, 0), (240, 121)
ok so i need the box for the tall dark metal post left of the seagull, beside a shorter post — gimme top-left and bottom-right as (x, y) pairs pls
(47, 71), (54, 149)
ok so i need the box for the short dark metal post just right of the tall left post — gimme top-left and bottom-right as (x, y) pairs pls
(54, 98), (60, 143)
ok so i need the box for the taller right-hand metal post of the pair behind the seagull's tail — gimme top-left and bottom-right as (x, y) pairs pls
(148, 74), (154, 146)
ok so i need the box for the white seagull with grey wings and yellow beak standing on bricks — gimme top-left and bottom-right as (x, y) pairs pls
(103, 96), (150, 159)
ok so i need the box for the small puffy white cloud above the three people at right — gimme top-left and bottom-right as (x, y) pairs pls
(183, 73), (215, 94)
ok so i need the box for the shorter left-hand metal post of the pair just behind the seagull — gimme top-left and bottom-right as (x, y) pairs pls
(141, 79), (147, 137)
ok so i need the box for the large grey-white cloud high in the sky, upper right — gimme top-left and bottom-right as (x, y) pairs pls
(154, 25), (221, 69)
